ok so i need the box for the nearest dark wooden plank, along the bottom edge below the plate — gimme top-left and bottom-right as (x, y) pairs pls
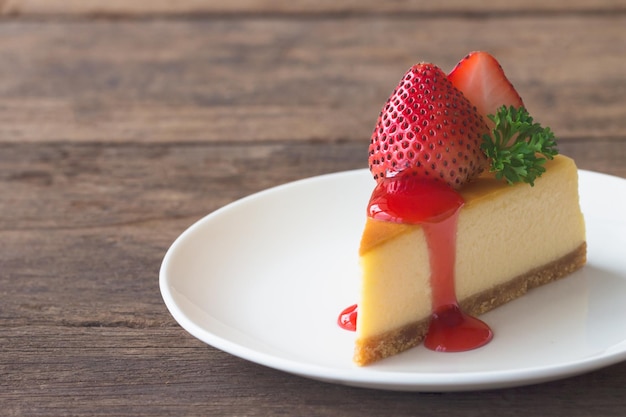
(0, 326), (626, 417)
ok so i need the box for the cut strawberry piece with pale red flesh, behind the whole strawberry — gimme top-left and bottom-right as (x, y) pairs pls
(448, 51), (524, 122)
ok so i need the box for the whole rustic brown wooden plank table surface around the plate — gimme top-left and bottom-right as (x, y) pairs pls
(0, 0), (626, 417)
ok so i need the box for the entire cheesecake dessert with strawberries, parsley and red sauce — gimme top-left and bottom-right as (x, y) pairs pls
(339, 52), (586, 365)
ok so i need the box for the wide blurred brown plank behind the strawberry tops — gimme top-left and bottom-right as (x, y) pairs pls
(0, 14), (626, 143)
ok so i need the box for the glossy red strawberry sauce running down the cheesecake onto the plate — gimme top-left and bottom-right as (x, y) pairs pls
(338, 176), (493, 352)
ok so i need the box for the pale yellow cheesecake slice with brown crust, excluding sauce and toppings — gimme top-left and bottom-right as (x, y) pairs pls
(354, 155), (586, 365)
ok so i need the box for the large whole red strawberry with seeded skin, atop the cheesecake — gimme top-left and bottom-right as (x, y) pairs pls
(369, 63), (489, 189)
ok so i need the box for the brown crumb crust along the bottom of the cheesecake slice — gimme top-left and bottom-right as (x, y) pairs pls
(354, 242), (587, 366)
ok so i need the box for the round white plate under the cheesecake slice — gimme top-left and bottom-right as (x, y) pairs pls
(160, 170), (626, 391)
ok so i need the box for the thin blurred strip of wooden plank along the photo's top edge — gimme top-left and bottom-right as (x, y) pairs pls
(0, 0), (626, 17)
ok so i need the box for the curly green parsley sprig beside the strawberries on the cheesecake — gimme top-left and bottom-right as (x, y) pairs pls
(481, 106), (559, 186)
